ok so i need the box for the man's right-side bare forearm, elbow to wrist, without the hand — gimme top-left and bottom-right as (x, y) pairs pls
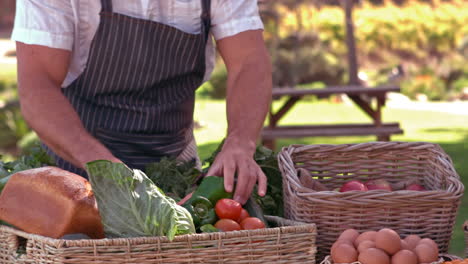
(227, 46), (272, 153)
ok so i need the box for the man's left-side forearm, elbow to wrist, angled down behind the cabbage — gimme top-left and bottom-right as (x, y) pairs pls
(19, 76), (116, 168)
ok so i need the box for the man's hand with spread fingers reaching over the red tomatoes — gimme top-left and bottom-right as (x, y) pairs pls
(207, 138), (267, 204)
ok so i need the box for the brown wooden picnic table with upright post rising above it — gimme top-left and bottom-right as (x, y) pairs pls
(262, 0), (403, 149)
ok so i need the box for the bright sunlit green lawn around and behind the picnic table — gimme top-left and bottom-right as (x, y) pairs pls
(195, 100), (468, 256)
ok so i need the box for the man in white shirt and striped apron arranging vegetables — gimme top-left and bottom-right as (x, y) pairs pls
(12, 0), (271, 203)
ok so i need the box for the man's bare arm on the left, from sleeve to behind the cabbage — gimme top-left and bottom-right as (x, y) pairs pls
(16, 42), (120, 168)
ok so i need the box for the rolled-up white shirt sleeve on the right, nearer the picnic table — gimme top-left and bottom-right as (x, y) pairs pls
(211, 0), (263, 40)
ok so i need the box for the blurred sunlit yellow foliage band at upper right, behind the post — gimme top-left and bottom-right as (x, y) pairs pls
(270, 0), (468, 58)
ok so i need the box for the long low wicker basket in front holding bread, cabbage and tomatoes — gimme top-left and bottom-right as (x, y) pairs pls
(0, 216), (316, 264)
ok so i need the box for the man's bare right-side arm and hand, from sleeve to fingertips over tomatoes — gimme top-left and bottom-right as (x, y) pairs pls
(208, 30), (272, 204)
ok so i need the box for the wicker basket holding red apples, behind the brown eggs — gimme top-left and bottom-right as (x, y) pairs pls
(278, 142), (464, 259)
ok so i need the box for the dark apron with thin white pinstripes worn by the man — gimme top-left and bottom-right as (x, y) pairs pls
(46, 0), (211, 177)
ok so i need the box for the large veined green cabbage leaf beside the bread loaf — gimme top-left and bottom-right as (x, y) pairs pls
(86, 160), (195, 240)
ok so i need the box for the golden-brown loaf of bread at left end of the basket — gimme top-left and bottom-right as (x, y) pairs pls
(0, 167), (104, 238)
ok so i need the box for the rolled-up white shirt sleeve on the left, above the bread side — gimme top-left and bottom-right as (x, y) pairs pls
(11, 0), (74, 50)
